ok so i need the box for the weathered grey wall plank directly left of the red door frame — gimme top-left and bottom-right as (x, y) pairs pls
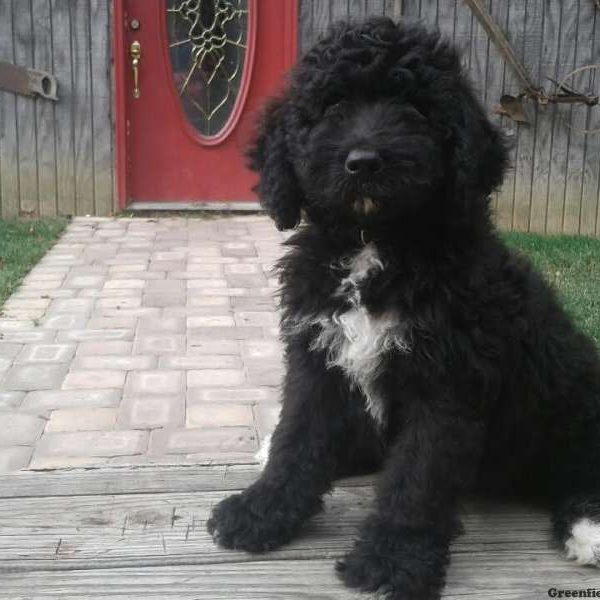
(90, 0), (113, 216)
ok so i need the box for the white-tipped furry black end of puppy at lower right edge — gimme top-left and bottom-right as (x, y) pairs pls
(553, 491), (600, 567)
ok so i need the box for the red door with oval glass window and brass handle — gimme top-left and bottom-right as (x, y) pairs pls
(115, 0), (298, 207)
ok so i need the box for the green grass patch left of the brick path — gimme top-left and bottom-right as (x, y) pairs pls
(0, 219), (67, 308)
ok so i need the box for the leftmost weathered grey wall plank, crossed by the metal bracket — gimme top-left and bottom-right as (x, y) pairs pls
(0, 1), (19, 219)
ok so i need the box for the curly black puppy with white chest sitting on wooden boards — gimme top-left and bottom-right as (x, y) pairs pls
(208, 18), (600, 600)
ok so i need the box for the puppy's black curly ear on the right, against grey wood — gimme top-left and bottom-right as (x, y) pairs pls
(449, 83), (508, 203)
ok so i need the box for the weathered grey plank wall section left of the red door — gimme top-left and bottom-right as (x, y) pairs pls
(0, 0), (114, 218)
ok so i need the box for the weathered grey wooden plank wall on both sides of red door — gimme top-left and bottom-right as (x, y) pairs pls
(0, 0), (600, 235)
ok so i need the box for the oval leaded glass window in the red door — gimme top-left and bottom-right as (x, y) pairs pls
(167, 0), (254, 138)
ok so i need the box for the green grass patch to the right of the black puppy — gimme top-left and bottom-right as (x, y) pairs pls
(504, 233), (600, 346)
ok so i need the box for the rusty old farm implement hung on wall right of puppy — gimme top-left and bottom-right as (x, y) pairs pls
(464, 0), (600, 123)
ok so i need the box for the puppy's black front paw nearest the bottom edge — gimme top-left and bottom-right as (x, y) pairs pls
(336, 530), (446, 600)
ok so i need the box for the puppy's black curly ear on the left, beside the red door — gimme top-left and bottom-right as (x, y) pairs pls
(247, 98), (302, 230)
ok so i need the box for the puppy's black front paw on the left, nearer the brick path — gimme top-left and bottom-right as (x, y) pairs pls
(206, 486), (318, 552)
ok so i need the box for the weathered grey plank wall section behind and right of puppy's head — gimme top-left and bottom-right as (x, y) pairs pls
(300, 0), (600, 235)
